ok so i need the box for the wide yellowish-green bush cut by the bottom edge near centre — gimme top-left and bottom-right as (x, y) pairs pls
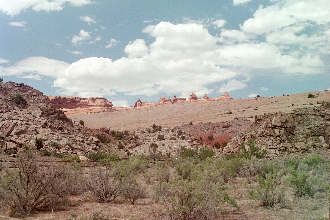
(155, 172), (236, 220)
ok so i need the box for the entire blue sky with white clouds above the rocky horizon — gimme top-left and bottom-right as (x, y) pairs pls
(0, 0), (330, 106)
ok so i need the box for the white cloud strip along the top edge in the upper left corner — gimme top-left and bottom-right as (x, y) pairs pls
(0, 0), (92, 16)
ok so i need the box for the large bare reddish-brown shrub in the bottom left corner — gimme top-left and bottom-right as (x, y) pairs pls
(0, 152), (70, 217)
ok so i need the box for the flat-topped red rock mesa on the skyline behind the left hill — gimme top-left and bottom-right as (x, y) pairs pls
(49, 96), (113, 115)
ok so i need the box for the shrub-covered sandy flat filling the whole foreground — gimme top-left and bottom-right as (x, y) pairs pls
(0, 144), (330, 220)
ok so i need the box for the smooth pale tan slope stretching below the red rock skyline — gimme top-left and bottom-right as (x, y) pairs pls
(68, 91), (330, 130)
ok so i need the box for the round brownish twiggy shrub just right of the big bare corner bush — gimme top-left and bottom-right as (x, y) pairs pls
(87, 168), (120, 202)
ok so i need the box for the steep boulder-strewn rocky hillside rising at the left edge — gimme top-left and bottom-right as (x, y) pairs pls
(0, 82), (99, 155)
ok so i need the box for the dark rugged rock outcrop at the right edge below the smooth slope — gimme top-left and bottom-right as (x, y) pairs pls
(223, 105), (330, 158)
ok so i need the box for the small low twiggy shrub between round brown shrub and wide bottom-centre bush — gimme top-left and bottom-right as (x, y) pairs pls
(120, 176), (146, 205)
